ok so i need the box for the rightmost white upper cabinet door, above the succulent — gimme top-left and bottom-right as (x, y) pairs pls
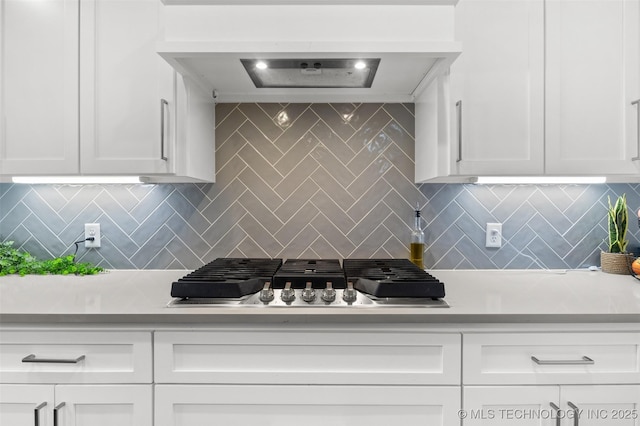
(546, 0), (640, 175)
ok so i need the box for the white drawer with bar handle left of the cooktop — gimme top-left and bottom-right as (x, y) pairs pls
(0, 331), (152, 383)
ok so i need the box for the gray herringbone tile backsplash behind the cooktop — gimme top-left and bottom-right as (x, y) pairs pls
(0, 104), (640, 269)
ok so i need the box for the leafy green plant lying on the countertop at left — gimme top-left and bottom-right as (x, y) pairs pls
(0, 241), (104, 276)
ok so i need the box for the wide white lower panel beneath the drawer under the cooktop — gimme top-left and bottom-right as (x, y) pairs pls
(155, 385), (460, 426)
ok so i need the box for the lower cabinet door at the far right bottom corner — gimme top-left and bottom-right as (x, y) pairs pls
(560, 385), (640, 426)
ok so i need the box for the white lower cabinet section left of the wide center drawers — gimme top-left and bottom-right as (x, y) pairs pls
(0, 330), (153, 426)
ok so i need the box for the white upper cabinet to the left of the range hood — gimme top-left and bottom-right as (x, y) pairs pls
(0, 0), (215, 182)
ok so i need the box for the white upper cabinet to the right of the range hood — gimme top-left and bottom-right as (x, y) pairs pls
(416, 0), (640, 181)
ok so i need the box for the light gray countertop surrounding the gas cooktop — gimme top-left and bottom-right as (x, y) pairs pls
(0, 270), (640, 325)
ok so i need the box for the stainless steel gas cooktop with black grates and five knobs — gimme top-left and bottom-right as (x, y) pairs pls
(168, 258), (449, 307)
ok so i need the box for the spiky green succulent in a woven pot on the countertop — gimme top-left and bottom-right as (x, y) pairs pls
(600, 194), (634, 274)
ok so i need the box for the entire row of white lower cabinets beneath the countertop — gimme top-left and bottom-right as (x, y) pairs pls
(0, 324), (640, 426)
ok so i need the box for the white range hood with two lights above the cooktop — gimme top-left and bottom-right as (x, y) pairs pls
(157, 4), (461, 102)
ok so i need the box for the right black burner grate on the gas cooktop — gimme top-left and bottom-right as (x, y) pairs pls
(342, 259), (444, 299)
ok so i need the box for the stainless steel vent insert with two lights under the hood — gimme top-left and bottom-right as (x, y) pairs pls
(240, 58), (380, 89)
